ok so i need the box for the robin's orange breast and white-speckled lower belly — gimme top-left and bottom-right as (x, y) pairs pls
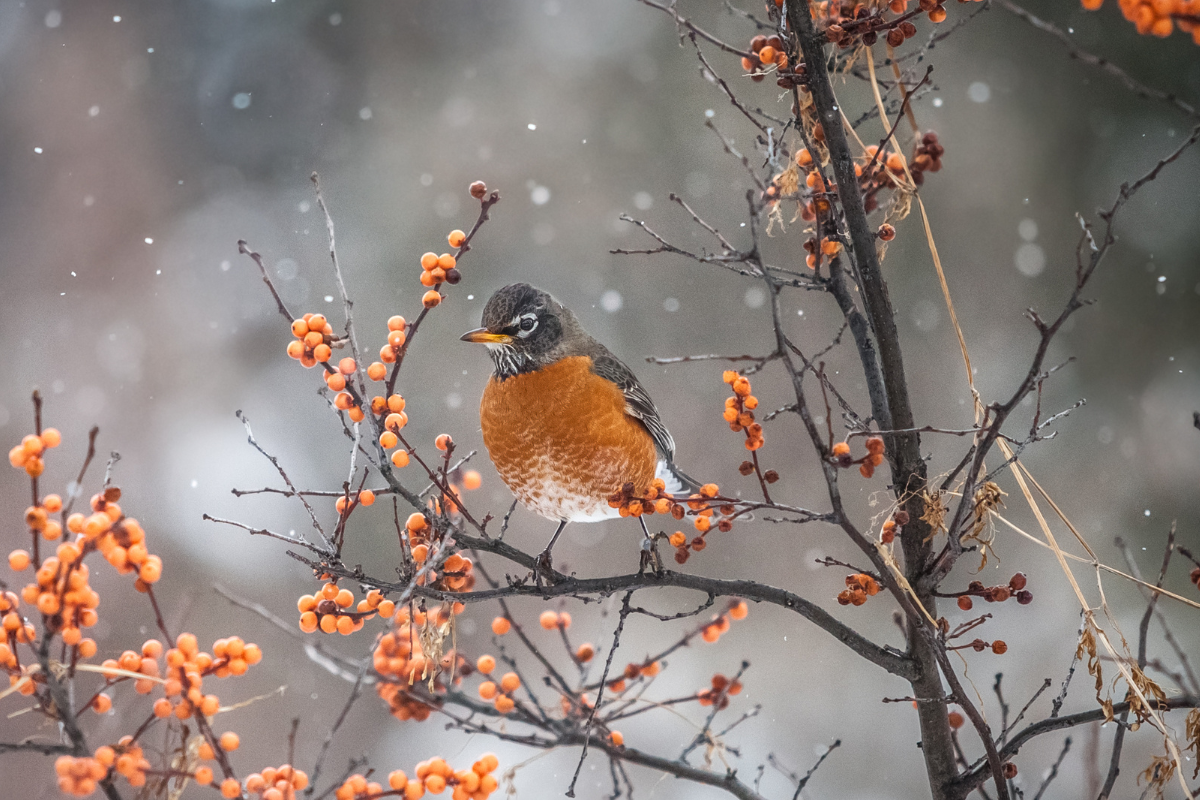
(479, 356), (658, 522)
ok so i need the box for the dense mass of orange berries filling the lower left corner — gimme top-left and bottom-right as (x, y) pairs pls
(7, 417), (274, 800)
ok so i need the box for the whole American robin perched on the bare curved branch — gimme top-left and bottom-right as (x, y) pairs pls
(462, 283), (697, 569)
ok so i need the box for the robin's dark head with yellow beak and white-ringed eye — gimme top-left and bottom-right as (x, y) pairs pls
(462, 283), (590, 379)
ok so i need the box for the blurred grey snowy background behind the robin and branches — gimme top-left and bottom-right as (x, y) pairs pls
(0, 0), (1200, 798)
